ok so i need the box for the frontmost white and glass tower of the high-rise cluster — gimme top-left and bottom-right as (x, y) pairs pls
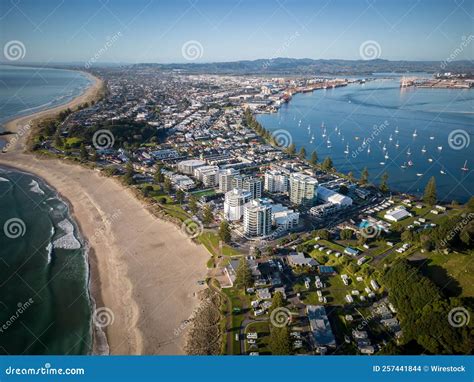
(244, 199), (272, 237)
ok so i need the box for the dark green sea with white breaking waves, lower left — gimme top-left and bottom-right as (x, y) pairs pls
(0, 168), (91, 354)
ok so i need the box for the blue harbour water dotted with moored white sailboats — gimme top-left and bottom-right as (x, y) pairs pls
(257, 78), (474, 202)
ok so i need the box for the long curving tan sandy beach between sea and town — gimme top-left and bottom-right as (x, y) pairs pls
(0, 70), (209, 354)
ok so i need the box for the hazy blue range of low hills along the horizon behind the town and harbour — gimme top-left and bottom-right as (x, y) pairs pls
(135, 58), (474, 75)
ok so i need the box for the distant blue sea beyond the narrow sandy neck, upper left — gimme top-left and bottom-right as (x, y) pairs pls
(0, 65), (91, 124)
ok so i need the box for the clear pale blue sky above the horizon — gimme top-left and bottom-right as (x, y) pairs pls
(0, 0), (474, 66)
